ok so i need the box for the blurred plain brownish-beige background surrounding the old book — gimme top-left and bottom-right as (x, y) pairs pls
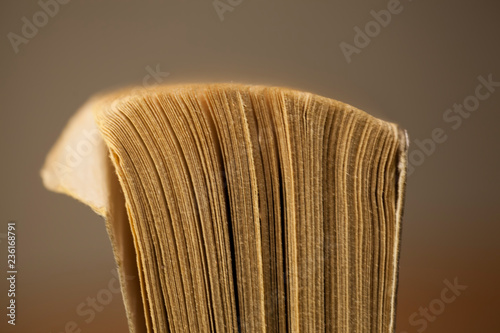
(0, 0), (500, 333)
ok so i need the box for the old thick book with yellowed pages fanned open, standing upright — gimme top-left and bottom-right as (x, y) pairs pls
(41, 84), (408, 332)
